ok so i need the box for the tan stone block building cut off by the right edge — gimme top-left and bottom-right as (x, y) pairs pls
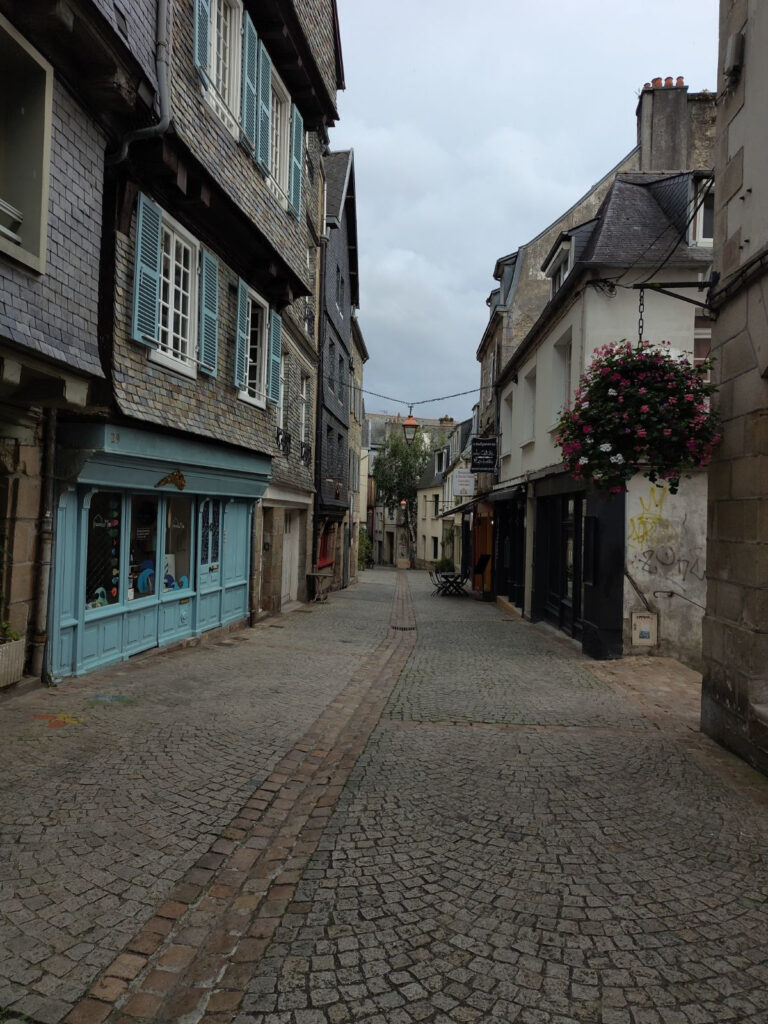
(701, 0), (768, 772)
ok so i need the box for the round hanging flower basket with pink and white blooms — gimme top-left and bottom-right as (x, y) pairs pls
(555, 341), (720, 495)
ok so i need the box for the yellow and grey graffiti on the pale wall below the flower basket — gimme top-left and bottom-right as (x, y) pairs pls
(627, 484), (705, 590)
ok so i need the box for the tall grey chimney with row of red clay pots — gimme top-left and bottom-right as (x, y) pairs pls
(636, 75), (690, 171)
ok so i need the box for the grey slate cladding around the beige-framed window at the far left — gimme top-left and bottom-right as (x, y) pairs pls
(0, 76), (106, 377)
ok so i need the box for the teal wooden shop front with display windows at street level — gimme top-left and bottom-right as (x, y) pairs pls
(48, 424), (271, 679)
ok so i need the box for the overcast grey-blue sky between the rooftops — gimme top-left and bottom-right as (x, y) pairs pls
(331, 0), (718, 419)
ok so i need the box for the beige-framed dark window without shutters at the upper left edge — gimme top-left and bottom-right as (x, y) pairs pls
(0, 14), (53, 273)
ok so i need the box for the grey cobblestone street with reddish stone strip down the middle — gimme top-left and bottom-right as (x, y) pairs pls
(0, 568), (768, 1024)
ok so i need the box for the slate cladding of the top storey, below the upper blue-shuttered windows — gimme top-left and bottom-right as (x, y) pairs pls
(171, 0), (316, 292)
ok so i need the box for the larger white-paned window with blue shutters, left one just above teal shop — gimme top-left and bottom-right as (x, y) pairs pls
(132, 195), (218, 377)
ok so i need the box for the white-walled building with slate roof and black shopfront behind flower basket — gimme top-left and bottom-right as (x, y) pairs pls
(474, 78), (715, 665)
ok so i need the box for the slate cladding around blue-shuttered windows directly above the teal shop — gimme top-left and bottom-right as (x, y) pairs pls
(113, 205), (312, 490)
